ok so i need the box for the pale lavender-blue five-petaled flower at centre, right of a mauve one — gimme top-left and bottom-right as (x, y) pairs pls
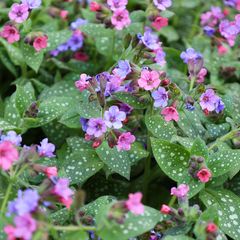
(104, 106), (126, 129)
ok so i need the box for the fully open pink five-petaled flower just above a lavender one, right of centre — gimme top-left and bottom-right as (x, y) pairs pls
(138, 70), (160, 90)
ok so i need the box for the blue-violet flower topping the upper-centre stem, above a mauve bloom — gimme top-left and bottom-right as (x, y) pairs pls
(138, 28), (161, 50)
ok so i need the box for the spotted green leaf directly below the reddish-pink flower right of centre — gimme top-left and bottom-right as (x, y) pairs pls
(145, 114), (177, 140)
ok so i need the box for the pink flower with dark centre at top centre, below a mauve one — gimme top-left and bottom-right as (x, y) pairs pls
(111, 9), (131, 30)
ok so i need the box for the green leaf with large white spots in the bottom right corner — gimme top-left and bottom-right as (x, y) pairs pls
(200, 189), (240, 240)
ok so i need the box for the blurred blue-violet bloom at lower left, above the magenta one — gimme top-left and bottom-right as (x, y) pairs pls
(8, 189), (40, 216)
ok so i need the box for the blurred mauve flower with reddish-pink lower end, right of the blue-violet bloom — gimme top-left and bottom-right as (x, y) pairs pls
(52, 178), (74, 208)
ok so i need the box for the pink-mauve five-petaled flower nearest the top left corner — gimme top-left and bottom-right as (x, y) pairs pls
(8, 3), (29, 23)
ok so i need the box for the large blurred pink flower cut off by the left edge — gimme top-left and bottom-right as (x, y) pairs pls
(0, 141), (19, 171)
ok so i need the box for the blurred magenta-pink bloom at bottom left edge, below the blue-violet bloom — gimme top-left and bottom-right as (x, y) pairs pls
(4, 214), (37, 240)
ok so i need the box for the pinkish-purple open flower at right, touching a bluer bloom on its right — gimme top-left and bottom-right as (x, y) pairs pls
(200, 89), (219, 112)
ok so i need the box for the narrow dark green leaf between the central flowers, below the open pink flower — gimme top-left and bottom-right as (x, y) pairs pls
(114, 92), (147, 109)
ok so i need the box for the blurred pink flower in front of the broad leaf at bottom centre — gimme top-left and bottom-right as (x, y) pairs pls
(125, 192), (144, 215)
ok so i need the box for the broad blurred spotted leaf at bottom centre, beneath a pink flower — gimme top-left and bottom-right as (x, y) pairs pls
(96, 206), (163, 240)
